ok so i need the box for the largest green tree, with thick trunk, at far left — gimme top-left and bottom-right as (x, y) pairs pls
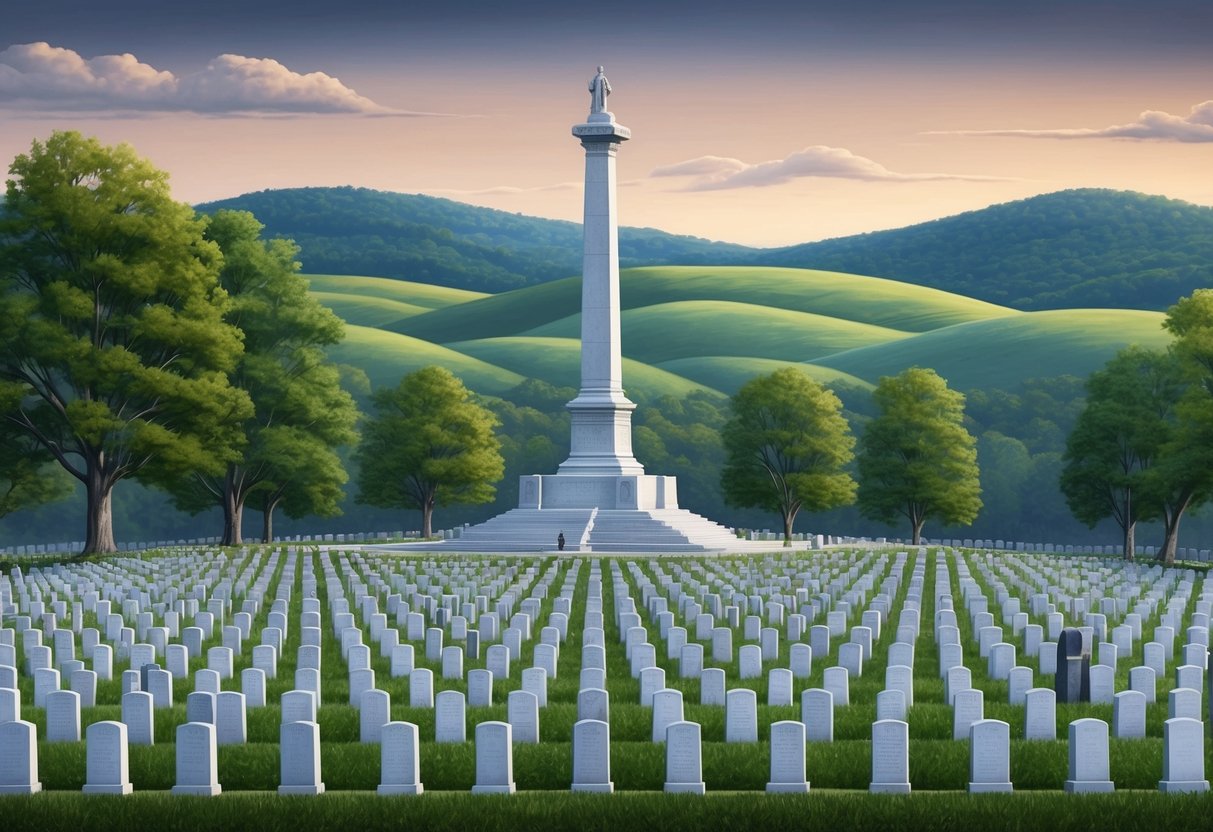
(0, 132), (251, 554)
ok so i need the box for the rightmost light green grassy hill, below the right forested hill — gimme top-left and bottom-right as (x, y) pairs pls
(814, 309), (1171, 389)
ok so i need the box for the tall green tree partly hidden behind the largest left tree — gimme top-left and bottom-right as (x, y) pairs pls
(169, 211), (358, 546)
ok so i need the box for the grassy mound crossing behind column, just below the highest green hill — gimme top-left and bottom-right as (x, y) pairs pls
(526, 301), (909, 364)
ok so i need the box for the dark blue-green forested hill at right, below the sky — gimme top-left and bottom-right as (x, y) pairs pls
(757, 189), (1213, 309)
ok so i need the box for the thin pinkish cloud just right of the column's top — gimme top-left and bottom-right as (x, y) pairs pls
(649, 144), (997, 190)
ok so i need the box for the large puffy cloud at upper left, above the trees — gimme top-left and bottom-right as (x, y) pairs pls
(0, 42), (409, 115)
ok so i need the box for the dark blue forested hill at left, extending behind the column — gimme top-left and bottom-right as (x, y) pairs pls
(198, 187), (758, 292)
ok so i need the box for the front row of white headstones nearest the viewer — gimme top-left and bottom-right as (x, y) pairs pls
(0, 718), (1208, 796)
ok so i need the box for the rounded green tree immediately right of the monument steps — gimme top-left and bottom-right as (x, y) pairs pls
(721, 367), (855, 546)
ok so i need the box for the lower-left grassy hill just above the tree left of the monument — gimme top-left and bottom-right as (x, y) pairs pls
(329, 325), (524, 394)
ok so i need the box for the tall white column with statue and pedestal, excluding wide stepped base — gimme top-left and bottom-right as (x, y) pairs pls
(559, 67), (644, 475)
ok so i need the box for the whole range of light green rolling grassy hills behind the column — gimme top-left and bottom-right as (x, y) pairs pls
(311, 266), (1169, 399)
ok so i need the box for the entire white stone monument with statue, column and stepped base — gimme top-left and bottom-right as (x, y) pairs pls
(443, 67), (739, 553)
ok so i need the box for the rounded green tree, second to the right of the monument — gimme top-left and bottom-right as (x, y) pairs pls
(859, 367), (981, 545)
